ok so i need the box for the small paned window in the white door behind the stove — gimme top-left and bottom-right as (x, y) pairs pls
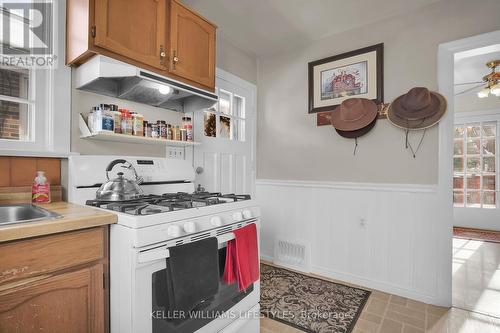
(204, 88), (245, 141)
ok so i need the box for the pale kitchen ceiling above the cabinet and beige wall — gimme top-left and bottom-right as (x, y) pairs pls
(183, 0), (439, 56)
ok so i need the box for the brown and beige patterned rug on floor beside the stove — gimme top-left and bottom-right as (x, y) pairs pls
(260, 264), (370, 333)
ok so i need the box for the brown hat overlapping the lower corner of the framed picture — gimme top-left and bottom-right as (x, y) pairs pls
(330, 98), (378, 132)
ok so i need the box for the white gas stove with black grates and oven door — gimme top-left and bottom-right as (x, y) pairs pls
(68, 155), (260, 333)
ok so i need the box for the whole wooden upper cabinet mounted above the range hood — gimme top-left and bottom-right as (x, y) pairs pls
(66, 0), (217, 91)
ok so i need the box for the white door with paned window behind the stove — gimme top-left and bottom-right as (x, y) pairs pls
(194, 70), (256, 196)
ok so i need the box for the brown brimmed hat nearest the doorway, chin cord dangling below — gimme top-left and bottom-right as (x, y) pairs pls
(387, 87), (447, 130)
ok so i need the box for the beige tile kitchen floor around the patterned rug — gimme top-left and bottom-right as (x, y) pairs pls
(261, 252), (500, 333)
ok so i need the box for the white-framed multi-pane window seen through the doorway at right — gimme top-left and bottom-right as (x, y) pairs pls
(453, 119), (498, 208)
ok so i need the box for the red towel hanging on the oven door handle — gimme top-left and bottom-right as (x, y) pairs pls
(223, 223), (260, 291)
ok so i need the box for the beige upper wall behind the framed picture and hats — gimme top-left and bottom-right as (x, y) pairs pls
(257, 0), (500, 184)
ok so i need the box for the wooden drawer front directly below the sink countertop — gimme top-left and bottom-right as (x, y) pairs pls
(0, 227), (107, 284)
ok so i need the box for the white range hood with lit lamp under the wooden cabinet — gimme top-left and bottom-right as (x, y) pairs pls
(75, 55), (218, 112)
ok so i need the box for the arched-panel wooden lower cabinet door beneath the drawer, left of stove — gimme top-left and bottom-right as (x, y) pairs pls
(0, 264), (105, 333)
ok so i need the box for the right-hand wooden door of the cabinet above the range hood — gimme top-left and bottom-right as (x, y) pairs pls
(169, 0), (215, 88)
